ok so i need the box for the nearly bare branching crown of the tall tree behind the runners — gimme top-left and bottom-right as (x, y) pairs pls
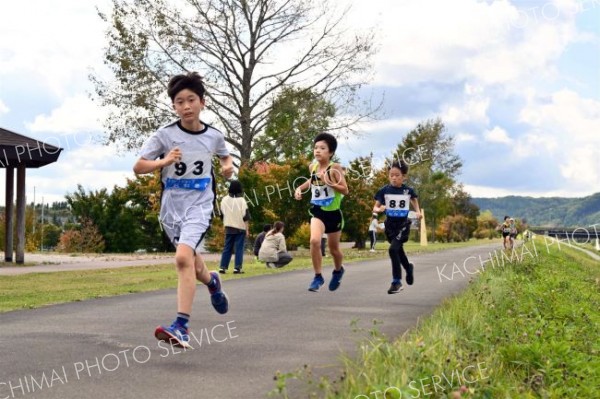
(91, 0), (374, 164)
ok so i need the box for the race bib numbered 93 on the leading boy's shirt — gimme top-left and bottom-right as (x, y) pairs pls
(163, 150), (212, 191)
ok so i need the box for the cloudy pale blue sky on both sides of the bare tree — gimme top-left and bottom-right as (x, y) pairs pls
(0, 0), (600, 204)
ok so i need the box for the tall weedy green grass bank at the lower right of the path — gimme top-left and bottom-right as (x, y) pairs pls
(272, 241), (600, 399)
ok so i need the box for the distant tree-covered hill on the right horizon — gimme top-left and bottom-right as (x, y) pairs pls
(473, 193), (600, 231)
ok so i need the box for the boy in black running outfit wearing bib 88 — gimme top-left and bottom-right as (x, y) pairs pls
(373, 161), (421, 294)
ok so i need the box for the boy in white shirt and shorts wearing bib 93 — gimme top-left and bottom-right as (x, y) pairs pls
(133, 72), (233, 348)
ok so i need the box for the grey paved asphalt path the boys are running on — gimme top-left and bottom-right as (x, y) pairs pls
(0, 244), (498, 399)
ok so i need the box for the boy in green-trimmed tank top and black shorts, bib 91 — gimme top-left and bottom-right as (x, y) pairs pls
(294, 133), (348, 292)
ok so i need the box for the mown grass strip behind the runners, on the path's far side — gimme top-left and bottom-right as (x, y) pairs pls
(0, 240), (499, 312)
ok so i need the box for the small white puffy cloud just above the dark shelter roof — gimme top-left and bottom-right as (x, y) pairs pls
(25, 94), (107, 134)
